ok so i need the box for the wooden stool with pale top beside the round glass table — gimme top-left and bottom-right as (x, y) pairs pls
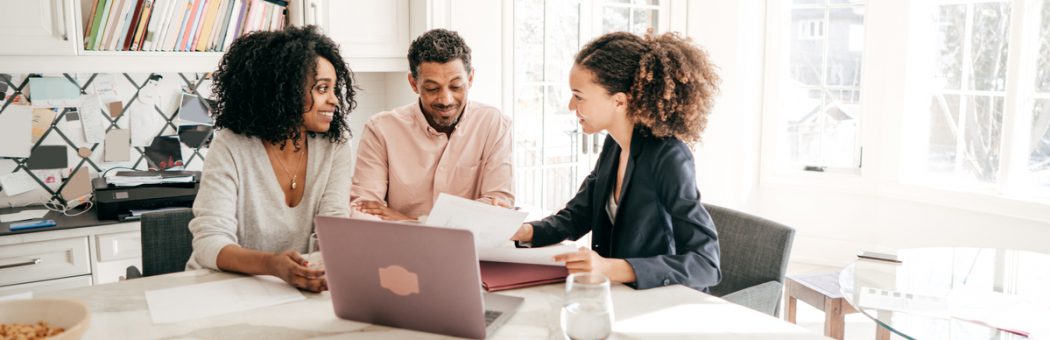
(784, 272), (889, 340)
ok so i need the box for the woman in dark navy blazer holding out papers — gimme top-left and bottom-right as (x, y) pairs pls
(512, 33), (721, 291)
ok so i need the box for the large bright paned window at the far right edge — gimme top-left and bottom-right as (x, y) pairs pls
(905, 0), (1050, 196)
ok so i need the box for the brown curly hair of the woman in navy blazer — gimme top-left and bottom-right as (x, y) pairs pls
(575, 31), (720, 144)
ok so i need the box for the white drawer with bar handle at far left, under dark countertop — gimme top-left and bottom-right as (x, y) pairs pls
(0, 236), (91, 286)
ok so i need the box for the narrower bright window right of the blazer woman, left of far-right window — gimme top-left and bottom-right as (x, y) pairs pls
(768, 0), (864, 171)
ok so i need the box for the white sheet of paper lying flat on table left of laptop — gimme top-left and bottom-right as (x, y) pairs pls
(146, 277), (306, 323)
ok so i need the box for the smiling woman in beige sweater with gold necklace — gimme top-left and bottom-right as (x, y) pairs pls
(186, 27), (356, 292)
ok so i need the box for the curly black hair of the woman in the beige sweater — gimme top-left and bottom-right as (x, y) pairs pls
(211, 26), (357, 149)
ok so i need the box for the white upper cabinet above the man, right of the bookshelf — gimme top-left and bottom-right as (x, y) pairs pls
(302, 0), (411, 71)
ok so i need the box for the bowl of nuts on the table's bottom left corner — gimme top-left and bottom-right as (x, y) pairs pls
(0, 299), (91, 340)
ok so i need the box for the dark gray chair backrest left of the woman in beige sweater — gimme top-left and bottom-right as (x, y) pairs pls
(141, 208), (193, 276)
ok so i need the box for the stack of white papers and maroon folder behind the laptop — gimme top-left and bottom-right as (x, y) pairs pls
(424, 193), (576, 292)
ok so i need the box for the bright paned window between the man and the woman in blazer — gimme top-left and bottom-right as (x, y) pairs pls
(508, 0), (668, 213)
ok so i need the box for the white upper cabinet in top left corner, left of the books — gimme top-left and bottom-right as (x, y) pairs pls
(0, 0), (77, 56)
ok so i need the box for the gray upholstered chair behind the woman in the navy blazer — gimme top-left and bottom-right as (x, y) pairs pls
(704, 204), (795, 316)
